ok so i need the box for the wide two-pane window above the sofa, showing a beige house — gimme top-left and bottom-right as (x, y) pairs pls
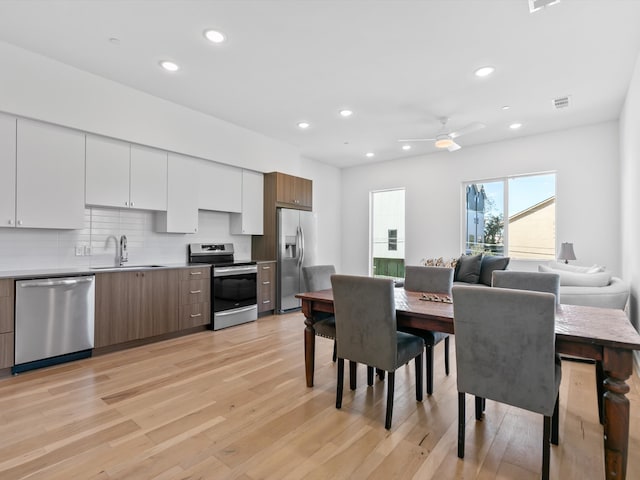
(464, 173), (556, 259)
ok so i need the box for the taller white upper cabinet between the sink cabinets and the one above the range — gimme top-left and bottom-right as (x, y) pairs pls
(156, 153), (198, 233)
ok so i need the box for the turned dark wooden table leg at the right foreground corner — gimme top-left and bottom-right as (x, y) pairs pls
(602, 348), (633, 480)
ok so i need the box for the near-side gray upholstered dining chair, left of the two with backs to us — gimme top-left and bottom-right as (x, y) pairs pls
(331, 275), (424, 430)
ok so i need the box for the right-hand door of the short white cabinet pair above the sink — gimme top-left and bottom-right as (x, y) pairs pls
(129, 145), (167, 210)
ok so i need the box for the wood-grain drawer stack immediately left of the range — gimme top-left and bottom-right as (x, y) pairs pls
(178, 267), (211, 330)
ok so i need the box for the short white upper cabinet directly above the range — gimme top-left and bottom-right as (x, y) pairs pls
(198, 160), (242, 213)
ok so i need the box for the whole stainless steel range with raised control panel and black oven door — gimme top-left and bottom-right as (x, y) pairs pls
(189, 243), (258, 330)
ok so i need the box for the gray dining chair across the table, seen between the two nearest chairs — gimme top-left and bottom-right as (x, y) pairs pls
(402, 265), (453, 395)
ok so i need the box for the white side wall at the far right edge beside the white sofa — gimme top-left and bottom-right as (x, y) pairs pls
(620, 51), (640, 331)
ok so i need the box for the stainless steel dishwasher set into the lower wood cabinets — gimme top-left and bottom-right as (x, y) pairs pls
(12, 275), (95, 373)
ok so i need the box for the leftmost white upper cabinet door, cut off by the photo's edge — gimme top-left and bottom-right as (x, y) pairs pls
(0, 115), (16, 227)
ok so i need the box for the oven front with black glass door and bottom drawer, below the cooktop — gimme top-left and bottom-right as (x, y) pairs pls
(211, 265), (258, 330)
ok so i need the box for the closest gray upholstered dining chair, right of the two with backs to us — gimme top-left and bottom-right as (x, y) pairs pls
(453, 286), (562, 480)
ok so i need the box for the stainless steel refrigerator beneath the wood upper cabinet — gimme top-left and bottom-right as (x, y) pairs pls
(276, 208), (317, 313)
